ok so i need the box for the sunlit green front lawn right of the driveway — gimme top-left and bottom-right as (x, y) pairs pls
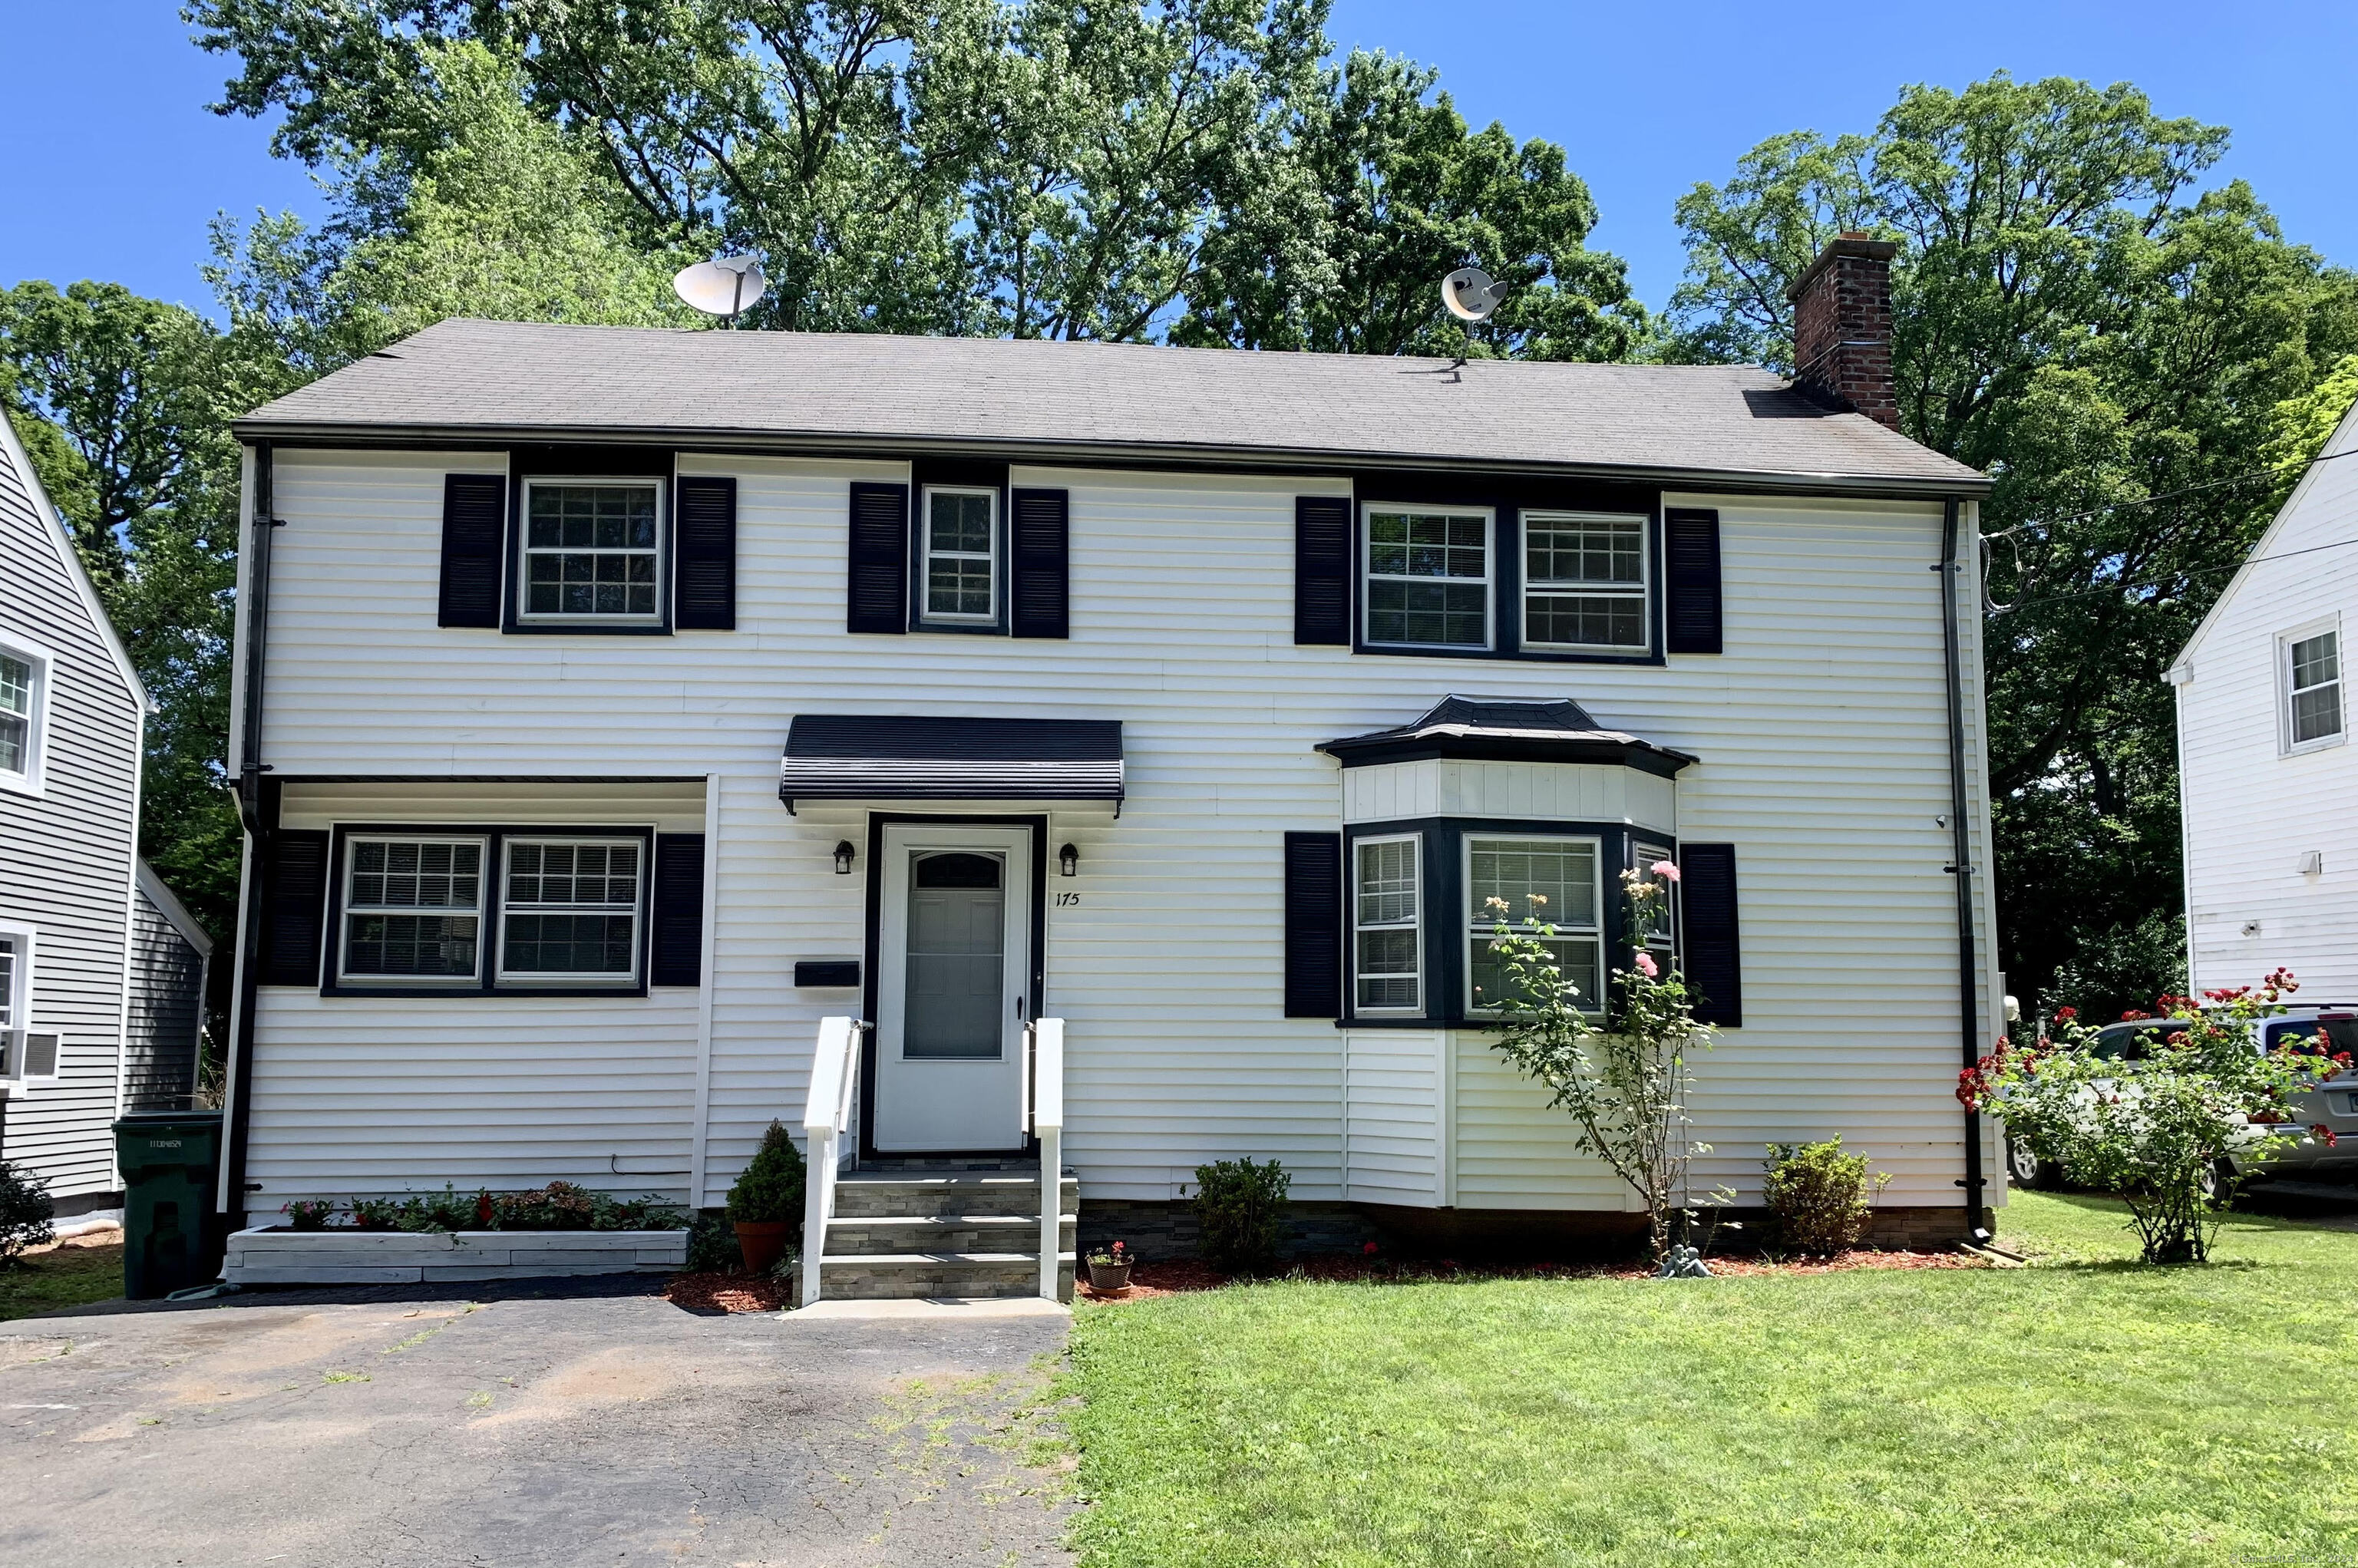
(1066, 1193), (2358, 1568)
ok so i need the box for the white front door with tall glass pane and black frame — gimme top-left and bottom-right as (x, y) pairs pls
(875, 823), (1033, 1153)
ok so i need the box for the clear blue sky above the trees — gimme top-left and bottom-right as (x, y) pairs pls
(0, 0), (2358, 320)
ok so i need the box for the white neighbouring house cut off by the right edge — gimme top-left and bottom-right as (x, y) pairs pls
(2169, 398), (2358, 1002)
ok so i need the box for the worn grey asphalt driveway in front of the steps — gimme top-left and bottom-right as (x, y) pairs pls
(0, 1280), (1071, 1568)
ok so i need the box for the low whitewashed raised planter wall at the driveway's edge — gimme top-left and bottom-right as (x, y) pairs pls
(222, 1226), (689, 1287)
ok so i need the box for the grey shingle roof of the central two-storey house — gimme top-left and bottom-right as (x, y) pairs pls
(238, 321), (1986, 495)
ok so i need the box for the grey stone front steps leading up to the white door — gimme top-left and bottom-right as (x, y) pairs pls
(818, 1163), (1080, 1302)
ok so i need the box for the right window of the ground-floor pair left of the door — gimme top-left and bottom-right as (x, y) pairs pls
(500, 840), (642, 981)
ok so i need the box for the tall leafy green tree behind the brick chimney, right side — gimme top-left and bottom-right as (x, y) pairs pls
(1667, 73), (2358, 1012)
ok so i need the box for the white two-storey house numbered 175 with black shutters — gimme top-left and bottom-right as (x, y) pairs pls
(224, 229), (2002, 1282)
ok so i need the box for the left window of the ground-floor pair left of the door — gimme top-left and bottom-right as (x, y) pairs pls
(345, 840), (484, 981)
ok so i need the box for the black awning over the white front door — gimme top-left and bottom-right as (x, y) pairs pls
(778, 715), (1122, 811)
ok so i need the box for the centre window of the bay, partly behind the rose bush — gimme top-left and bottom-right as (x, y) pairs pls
(1465, 835), (1603, 1012)
